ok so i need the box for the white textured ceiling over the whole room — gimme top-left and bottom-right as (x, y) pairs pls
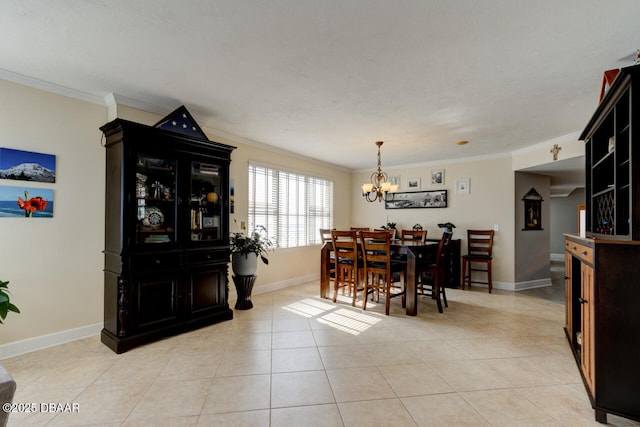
(0, 0), (640, 176)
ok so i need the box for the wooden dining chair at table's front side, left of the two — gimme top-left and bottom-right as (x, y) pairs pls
(331, 230), (364, 307)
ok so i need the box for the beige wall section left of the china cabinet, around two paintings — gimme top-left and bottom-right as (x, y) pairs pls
(0, 80), (107, 346)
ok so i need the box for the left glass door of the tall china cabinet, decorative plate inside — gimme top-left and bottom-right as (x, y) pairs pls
(134, 154), (176, 244)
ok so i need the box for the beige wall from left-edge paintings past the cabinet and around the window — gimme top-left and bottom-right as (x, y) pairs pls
(0, 84), (351, 359)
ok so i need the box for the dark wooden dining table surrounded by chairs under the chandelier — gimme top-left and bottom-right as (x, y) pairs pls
(320, 239), (439, 316)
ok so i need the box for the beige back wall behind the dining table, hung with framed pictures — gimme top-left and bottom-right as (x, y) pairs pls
(351, 157), (514, 288)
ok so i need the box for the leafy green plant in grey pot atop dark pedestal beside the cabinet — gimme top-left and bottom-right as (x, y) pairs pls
(230, 225), (274, 276)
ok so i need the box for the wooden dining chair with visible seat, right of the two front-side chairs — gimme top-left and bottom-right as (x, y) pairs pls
(360, 231), (406, 316)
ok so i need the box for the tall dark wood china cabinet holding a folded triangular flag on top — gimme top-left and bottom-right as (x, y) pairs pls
(100, 113), (235, 353)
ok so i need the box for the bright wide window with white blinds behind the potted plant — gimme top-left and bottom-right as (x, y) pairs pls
(247, 164), (333, 248)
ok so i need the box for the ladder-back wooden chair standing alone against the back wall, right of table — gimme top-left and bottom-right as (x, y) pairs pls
(462, 230), (494, 293)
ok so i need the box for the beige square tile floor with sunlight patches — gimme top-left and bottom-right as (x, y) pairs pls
(3, 282), (639, 427)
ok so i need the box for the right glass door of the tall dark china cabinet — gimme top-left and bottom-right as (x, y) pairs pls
(189, 161), (223, 241)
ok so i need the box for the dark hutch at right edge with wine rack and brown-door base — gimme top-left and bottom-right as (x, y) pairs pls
(565, 66), (640, 423)
